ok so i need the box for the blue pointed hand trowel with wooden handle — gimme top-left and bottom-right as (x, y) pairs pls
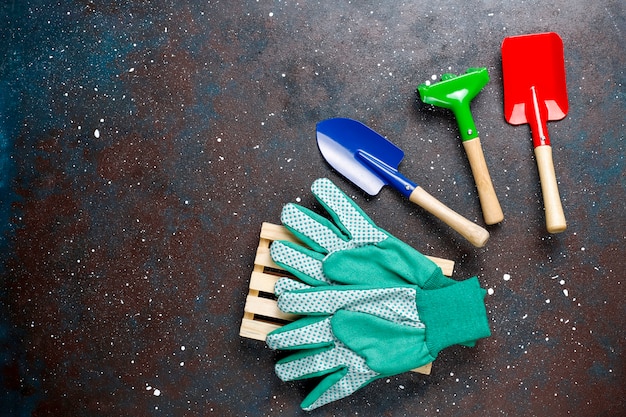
(317, 118), (489, 247)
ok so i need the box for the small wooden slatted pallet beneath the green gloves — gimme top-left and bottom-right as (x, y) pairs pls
(239, 222), (454, 374)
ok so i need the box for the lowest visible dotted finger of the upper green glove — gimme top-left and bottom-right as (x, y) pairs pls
(270, 241), (328, 286)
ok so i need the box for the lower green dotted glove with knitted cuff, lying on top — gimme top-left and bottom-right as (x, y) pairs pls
(267, 277), (490, 410)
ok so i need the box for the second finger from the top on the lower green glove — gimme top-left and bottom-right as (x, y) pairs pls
(265, 317), (334, 350)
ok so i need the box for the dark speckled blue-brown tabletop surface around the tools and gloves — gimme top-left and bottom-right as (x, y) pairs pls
(0, 0), (626, 416)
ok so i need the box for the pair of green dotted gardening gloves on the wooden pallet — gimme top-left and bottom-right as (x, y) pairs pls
(266, 178), (490, 410)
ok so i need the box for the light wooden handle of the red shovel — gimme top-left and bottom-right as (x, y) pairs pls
(535, 145), (567, 233)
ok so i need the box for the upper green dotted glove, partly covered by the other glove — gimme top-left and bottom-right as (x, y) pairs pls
(270, 178), (456, 289)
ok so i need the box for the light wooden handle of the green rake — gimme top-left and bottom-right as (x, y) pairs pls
(463, 137), (504, 224)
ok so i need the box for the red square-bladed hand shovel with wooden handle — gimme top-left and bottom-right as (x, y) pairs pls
(502, 32), (568, 233)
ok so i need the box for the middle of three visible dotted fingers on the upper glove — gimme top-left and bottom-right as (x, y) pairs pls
(280, 203), (347, 250)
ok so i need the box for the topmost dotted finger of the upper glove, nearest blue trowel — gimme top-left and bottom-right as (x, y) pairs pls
(311, 178), (388, 245)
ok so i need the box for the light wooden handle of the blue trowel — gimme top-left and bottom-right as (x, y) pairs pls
(409, 186), (489, 248)
